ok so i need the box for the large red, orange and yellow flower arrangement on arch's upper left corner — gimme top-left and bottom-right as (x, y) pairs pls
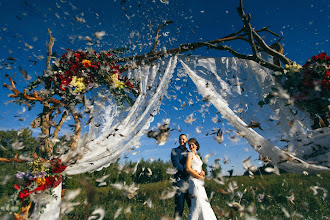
(28, 48), (138, 105)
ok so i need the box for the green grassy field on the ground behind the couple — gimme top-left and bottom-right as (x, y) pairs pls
(61, 172), (330, 220)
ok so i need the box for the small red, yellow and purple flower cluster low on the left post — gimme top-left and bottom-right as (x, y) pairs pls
(6, 158), (66, 215)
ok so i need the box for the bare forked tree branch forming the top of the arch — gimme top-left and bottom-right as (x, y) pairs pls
(116, 0), (292, 72)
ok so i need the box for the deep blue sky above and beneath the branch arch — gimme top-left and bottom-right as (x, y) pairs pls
(0, 0), (330, 174)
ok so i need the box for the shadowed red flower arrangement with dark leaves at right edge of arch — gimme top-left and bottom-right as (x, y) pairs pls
(261, 53), (330, 128)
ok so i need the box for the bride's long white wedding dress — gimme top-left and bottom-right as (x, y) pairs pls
(188, 154), (217, 220)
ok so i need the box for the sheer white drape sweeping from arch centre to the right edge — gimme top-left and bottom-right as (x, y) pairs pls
(179, 56), (330, 173)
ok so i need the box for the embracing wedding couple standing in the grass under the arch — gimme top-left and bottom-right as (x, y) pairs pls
(171, 134), (217, 220)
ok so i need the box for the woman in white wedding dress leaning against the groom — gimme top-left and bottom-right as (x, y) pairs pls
(186, 138), (217, 220)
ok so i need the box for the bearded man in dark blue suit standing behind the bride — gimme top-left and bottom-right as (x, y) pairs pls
(171, 134), (191, 219)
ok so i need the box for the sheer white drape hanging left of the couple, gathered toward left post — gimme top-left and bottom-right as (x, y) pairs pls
(62, 57), (177, 175)
